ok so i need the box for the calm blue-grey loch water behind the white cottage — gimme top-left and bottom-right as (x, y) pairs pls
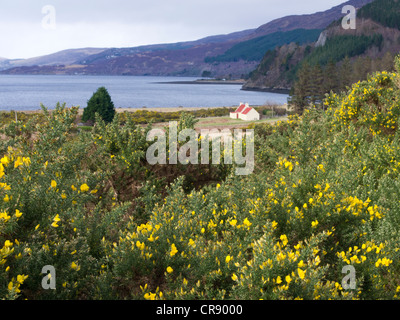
(0, 75), (288, 111)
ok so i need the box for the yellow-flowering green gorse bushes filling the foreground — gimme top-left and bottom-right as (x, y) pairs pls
(0, 55), (400, 299)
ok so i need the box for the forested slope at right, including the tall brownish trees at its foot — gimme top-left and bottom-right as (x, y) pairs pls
(244, 0), (400, 109)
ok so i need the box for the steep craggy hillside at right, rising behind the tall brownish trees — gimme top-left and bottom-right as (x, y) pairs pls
(243, 0), (400, 91)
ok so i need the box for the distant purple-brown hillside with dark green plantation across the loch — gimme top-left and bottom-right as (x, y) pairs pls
(0, 0), (371, 78)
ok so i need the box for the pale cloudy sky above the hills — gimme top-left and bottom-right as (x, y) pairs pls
(0, 0), (346, 59)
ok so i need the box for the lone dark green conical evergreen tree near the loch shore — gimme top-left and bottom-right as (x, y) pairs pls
(82, 87), (115, 123)
